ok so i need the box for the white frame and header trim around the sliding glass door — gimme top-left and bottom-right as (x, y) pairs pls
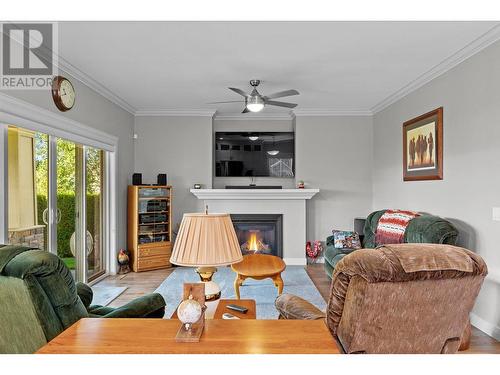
(0, 93), (118, 282)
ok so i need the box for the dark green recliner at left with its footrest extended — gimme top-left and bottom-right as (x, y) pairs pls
(0, 245), (165, 353)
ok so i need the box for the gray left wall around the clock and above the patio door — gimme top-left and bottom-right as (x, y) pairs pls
(1, 74), (134, 256)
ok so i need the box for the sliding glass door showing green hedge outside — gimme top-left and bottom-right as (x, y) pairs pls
(7, 126), (106, 282)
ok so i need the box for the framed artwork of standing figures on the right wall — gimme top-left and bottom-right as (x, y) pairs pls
(403, 107), (443, 181)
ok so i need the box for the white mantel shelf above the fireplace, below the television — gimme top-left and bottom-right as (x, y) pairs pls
(191, 189), (319, 200)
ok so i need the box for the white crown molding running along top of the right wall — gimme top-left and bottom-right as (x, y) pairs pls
(371, 25), (500, 114)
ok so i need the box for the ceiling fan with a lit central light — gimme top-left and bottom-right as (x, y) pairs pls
(208, 79), (299, 113)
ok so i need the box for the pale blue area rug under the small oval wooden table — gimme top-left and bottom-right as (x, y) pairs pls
(155, 266), (326, 319)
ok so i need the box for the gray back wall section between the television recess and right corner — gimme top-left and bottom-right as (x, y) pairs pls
(295, 116), (372, 241)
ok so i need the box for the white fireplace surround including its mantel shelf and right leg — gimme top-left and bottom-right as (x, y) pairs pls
(191, 189), (319, 265)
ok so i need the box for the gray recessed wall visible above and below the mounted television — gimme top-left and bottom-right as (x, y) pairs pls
(213, 117), (297, 189)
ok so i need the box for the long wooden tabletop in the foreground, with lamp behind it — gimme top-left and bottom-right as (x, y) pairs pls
(37, 318), (339, 354)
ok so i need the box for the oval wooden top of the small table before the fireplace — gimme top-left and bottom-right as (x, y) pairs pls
(231, 254), (286, 277)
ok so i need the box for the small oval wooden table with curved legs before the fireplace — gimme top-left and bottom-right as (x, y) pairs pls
(231, 254), (286, 299)
